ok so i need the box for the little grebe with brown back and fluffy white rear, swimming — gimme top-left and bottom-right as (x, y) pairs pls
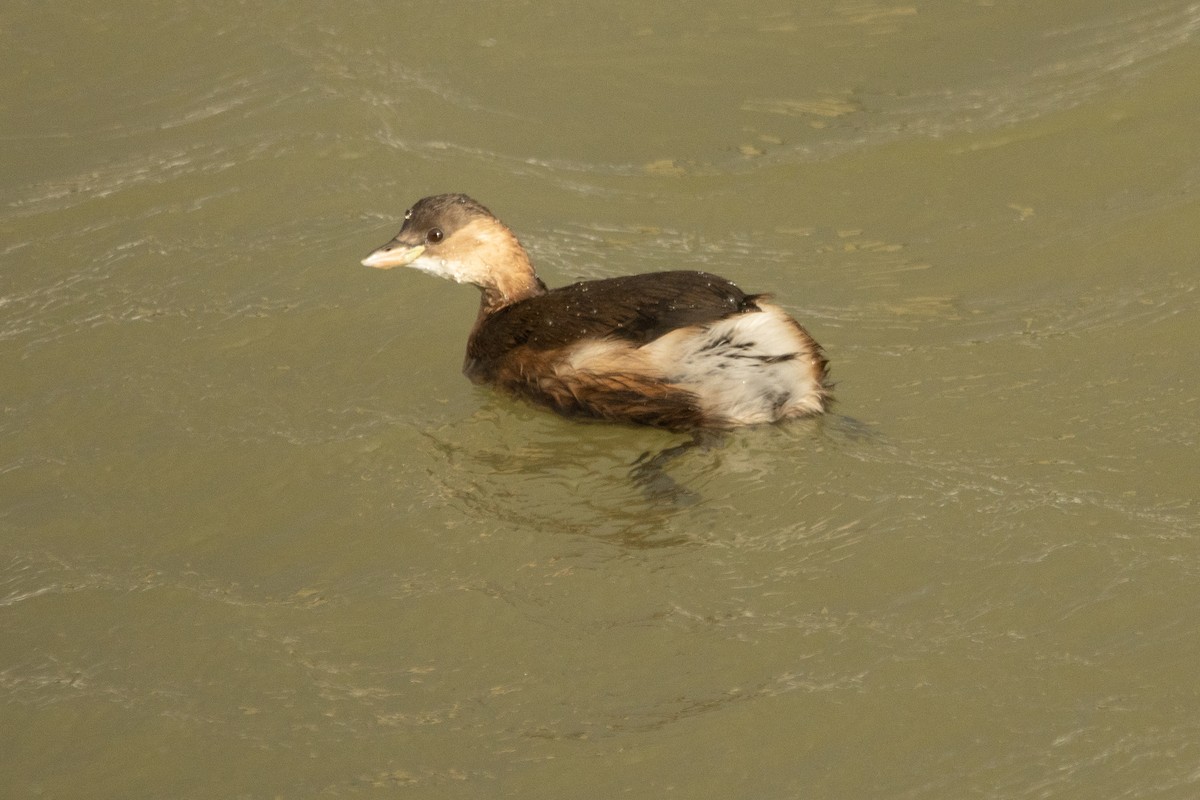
(362, 194), (829, 431)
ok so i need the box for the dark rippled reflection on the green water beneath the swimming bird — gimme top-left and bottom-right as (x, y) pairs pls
(398, 398), (881, 549)
